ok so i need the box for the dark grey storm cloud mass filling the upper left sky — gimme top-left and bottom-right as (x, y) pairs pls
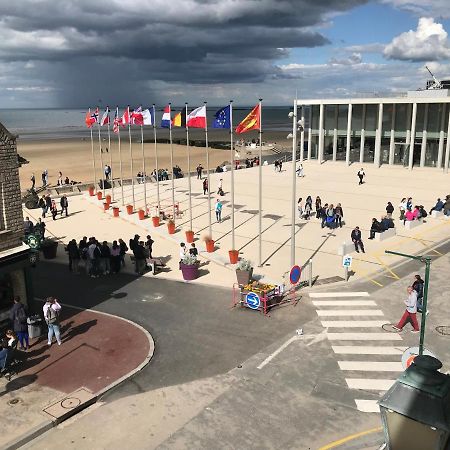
(0, 0), (366, 104)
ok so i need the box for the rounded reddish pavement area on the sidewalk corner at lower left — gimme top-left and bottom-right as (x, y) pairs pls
(19, 306), (150, 393)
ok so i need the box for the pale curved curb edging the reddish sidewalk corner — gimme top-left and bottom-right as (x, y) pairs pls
(0, 298), (155, 450)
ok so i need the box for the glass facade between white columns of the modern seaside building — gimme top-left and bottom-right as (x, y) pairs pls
(305, 97), (450, 167)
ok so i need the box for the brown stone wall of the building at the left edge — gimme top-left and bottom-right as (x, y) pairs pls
(0, 123), (23, 252)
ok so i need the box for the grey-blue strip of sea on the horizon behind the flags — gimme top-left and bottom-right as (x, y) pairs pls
(0, 105), (300, 140)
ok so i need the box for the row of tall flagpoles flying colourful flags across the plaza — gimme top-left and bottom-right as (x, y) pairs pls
(85, 99), (262, 265)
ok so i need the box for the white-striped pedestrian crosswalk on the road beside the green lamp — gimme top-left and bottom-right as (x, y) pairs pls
(309, 292), (406, 412)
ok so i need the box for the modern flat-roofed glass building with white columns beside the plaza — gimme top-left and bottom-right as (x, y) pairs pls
(296, 89), (450, 171)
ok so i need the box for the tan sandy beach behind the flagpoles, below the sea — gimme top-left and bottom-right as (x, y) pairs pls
(17, 132), (290, 190)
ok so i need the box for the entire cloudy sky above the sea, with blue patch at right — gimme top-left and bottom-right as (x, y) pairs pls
(0, 0), (450, 108)
